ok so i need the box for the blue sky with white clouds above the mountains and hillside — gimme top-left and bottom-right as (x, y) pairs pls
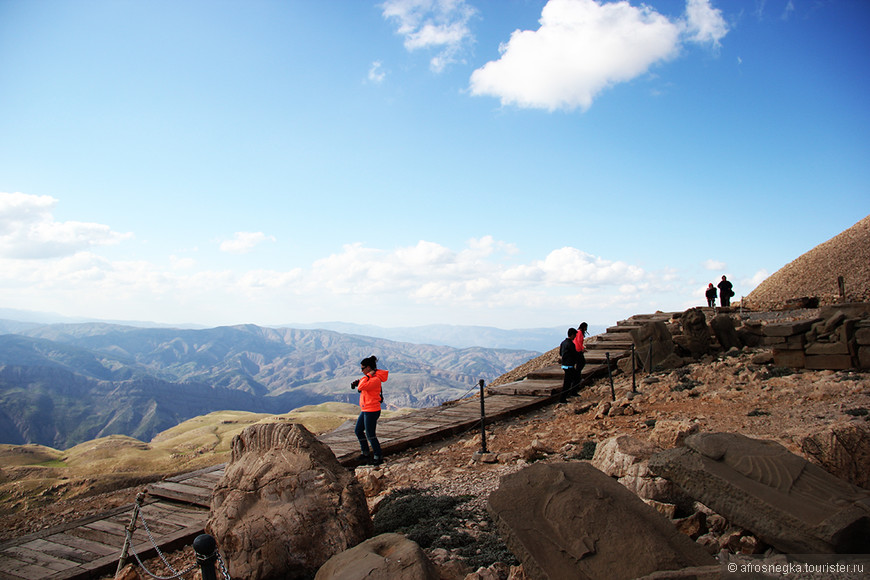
(0, 0), (870, 328)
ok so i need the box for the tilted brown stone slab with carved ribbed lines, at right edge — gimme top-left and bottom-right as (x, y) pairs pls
(649, 433), (870, 554)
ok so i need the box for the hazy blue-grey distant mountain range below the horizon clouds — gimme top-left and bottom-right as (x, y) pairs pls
(0, 320), (544, 449)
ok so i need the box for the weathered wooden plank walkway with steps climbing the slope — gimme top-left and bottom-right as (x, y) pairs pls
(0, 314), (669, 580)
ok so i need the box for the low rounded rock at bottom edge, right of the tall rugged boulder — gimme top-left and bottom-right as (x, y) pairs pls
(314, 534), (439, 580)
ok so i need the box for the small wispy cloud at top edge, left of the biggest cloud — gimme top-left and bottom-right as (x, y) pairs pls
(381, 0), (477, 72)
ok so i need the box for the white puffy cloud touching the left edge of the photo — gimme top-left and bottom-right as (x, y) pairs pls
(0, 192), (132, 259)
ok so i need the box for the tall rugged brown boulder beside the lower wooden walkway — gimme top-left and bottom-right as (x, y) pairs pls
(212, 423), (372, 580)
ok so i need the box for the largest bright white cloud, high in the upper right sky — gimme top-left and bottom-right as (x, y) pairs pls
(469, 0), (727, 111)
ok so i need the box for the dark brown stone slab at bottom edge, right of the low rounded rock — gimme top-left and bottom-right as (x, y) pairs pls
(489, 462), (715, 580)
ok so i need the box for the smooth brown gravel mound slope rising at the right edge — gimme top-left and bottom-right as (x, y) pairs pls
(744, 216), (870, 310)
